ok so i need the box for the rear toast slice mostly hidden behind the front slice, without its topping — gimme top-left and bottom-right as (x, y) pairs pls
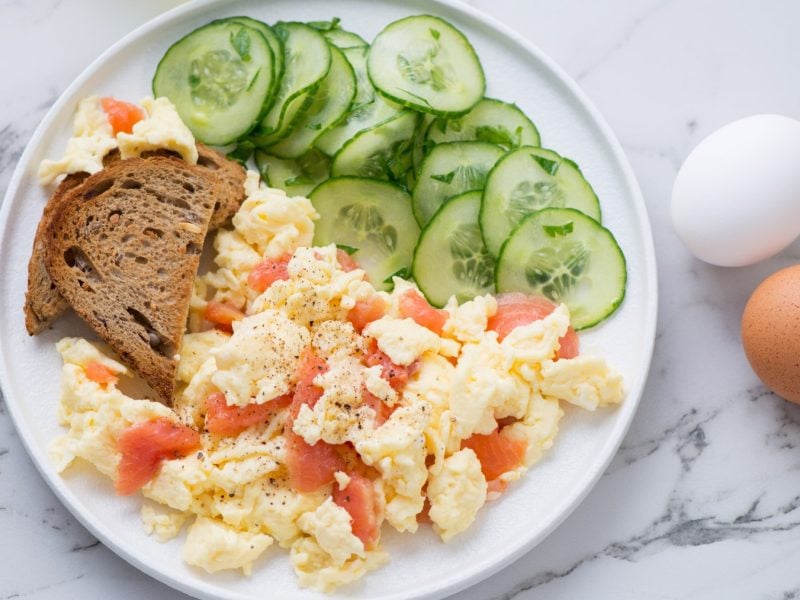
(24, 142), (245, 335)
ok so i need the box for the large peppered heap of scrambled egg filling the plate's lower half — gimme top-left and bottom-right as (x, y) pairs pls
(51, 166), (624, 591)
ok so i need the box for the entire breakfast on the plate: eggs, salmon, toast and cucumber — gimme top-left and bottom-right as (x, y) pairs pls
(26, 15), (626, 591)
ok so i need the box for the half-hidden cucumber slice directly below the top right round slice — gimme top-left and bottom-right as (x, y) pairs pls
(426, 98), (540, 150)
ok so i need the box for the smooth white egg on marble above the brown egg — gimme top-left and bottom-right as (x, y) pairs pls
(672, 115), (800, 267)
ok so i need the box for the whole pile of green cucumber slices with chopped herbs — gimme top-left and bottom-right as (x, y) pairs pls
(153, 15), (626, 329)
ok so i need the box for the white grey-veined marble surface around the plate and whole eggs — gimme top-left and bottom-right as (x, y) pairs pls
(0, 0), (800, 600)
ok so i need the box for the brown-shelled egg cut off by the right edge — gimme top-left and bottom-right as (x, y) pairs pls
(742, 265), (800, 403)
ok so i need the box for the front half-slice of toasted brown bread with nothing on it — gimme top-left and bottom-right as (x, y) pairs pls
(43, 157), (217, 404)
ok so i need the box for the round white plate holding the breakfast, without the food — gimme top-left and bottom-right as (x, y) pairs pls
(0, 0), (657, 600)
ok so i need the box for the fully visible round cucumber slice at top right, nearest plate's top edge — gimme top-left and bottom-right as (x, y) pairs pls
(367, 15), (486, 117)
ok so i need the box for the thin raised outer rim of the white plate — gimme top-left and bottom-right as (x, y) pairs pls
(0, 0), (658, 600)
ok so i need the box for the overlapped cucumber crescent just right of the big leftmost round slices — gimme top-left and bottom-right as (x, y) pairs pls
(254, 22), (331, 146)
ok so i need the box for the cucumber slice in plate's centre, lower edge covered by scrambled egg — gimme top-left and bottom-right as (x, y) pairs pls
(310, 177), (419, 290)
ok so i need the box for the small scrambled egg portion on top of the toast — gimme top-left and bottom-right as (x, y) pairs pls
(38, 91), (197, 186)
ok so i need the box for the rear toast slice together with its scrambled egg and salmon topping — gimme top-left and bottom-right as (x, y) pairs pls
(25, 96), (244, 335)
